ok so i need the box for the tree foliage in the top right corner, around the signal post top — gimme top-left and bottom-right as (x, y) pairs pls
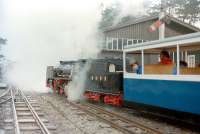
(147, 0), (200, 24)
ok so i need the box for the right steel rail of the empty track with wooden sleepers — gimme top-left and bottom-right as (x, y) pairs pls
(18, 90), (50, 134)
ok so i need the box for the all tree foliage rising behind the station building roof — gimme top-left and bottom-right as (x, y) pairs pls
(99, 0), (200, 29)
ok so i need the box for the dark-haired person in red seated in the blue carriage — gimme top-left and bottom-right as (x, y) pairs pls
(160, 50), (173, 65)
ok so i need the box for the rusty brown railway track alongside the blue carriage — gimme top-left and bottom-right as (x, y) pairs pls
(67, 101), (162, 134)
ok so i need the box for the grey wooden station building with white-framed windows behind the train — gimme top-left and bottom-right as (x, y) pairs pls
(99, 15), (200, 59)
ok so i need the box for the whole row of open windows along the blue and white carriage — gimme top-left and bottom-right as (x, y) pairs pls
(125, 43), (200, 76)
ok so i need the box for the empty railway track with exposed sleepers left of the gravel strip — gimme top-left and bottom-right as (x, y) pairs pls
(11, 90), (56, 134)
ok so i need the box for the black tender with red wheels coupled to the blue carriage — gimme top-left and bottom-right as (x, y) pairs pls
(84, 58), (123, 106)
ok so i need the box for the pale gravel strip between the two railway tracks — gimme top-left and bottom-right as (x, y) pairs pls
(35, 94), (121, 134)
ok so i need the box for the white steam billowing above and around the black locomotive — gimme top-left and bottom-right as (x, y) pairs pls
(0, 0), (150, 100)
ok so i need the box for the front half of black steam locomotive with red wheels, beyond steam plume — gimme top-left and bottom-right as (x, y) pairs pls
(46, 59), (86, 96)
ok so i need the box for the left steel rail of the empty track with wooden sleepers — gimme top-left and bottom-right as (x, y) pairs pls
(10, 89), (20, 134)
